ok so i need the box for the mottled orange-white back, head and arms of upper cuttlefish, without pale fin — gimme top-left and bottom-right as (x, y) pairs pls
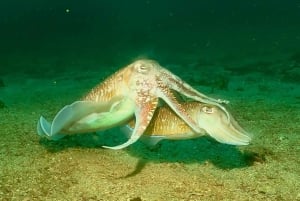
(83, 60), (229, 149)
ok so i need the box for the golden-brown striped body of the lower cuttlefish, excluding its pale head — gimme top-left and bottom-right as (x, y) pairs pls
(129, 102), (204, 136)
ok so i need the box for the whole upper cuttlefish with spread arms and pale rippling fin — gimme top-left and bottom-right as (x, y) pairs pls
(38, 59), (231, 149)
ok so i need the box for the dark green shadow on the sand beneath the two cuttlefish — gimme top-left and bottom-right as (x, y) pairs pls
(40, 131), (257, 177)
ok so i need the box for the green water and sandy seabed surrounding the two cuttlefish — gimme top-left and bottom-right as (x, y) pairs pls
(0, 0), (300, 201)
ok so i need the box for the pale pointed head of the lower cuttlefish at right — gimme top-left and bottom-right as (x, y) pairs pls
(196, 104), (251, 145)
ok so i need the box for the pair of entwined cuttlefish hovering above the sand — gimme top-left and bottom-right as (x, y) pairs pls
(37, 59), (251, 149)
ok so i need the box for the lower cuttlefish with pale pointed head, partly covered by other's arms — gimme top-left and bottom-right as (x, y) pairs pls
(129, 102), (251, 145)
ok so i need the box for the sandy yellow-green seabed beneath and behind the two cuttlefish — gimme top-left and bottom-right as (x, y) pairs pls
(0, 57), (300, 201)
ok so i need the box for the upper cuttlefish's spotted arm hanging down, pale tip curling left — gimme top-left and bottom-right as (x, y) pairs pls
(103, 98), (158, 149)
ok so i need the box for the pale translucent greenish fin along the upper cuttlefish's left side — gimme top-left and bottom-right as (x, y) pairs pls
(37, 97), (134, 140)
